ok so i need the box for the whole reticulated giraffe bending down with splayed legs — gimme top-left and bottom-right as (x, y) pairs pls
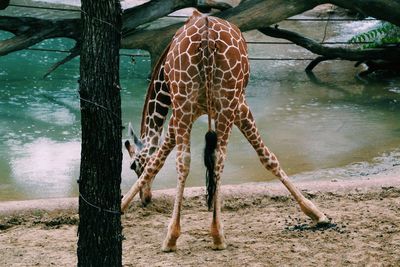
(121, 10), (329, 252)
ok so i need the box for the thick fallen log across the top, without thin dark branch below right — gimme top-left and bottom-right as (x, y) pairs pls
(0, 0), (400, 73)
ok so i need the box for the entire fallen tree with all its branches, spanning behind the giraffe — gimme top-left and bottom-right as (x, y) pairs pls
(0, 0), (400, 75)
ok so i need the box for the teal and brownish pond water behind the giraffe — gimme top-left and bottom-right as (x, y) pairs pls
(0, 7), (400, 200)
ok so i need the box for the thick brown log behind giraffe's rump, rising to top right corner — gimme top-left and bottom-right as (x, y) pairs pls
(122, 0), (400, 62)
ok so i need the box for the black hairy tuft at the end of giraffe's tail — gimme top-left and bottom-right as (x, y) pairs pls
(204, 130), (218, 210)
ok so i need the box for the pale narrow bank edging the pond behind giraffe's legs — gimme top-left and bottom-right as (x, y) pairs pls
(0, 166), (400, 215)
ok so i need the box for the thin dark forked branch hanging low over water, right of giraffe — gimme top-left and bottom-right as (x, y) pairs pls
(259, 27), (400, 70)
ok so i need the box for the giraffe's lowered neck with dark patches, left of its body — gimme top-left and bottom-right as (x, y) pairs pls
(140, 46), (171, 156)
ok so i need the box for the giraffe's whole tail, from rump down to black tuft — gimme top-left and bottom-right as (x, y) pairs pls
(201, 16), (218, 210)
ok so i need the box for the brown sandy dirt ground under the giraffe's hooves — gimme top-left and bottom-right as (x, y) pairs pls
(0, 176), (400, 266)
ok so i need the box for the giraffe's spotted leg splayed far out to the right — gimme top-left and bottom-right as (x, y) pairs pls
(235, 101), (329, 224)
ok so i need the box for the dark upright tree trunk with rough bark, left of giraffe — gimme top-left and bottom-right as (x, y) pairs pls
(77, 0), (122, 266)
